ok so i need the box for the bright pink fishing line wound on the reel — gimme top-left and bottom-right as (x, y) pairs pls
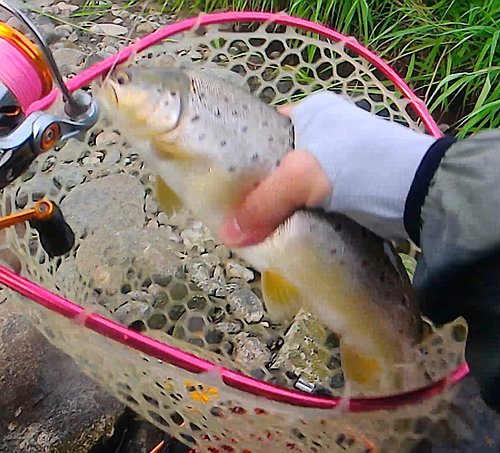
(0, 38), (43, 112)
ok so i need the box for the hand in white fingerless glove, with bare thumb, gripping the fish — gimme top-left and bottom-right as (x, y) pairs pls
(219, 92), (435, 247)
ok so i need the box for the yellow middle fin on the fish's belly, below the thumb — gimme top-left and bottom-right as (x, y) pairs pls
(262, 269), (302, 322)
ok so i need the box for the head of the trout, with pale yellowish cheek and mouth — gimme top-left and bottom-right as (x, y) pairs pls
(97, 67), (189, 139)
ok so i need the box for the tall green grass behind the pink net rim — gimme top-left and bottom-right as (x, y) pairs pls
(160, 0), (500, 136)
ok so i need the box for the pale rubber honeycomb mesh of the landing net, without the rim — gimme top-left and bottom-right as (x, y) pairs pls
(0, 18), (467, 453)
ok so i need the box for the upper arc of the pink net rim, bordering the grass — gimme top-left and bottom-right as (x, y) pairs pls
(27, 11), (442, 138)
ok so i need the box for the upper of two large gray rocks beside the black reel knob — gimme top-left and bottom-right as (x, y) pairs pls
(61, 175), (144, 237)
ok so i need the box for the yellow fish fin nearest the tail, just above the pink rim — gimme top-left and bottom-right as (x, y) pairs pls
(340, 340), (383, 390)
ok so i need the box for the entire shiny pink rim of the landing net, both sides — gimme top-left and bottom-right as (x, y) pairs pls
(0, 12), (469, 412)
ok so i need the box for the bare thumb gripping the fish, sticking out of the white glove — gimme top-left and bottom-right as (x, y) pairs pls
(219, 151), (331, 247)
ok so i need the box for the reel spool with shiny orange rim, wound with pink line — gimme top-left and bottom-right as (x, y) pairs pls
(0, 22), (53, 135)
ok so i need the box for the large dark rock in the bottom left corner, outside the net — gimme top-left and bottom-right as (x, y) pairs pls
(0, 294), (124, 453)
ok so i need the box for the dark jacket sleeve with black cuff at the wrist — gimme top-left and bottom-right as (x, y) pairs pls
(405, 131), (500, 411)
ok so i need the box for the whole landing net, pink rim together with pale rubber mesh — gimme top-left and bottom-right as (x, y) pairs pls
(0, 8), (468, 453)
